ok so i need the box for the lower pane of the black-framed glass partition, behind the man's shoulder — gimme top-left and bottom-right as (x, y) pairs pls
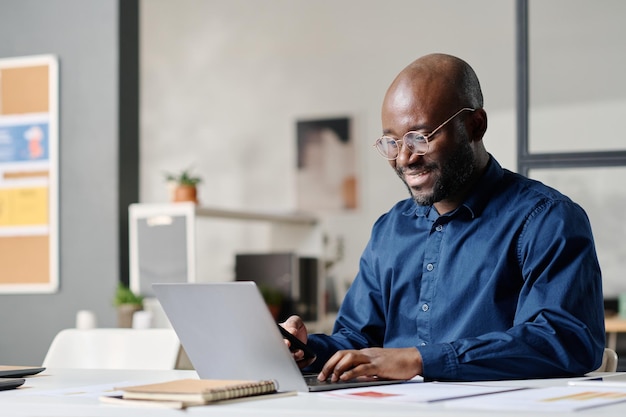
(529, 167), (626, 298)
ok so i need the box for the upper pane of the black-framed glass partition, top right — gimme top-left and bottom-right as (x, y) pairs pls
(528, 0), (626, 153)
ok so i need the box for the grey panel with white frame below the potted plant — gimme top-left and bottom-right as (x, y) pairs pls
(128, 203), (195, 297)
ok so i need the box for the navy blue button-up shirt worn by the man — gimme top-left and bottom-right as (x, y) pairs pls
(308, 158), (605, 380)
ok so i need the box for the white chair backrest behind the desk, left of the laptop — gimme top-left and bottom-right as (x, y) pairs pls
(43, 328), (180, 370)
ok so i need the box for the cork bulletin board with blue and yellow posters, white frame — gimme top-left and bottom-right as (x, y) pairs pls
(0, 55), (59, 293)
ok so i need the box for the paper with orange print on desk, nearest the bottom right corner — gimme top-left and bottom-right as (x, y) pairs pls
(445, 386), (626, 412)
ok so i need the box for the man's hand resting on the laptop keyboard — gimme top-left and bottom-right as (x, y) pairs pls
(317, 348), (423, 382)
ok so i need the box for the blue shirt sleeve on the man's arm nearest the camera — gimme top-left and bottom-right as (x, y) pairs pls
(418, 200), (605, 380)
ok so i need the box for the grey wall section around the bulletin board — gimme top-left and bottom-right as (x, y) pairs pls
(0, 0), (125, 365)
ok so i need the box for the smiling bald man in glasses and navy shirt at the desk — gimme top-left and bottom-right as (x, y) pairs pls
(283, 54), (605, 380)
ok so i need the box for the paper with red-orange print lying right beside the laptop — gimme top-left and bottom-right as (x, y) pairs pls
(320, 382), (526, 403)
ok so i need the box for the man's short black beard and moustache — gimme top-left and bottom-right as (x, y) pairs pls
(396, 138), (475, 206)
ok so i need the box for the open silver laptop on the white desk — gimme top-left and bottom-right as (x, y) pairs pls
(153, 281), (410, 392)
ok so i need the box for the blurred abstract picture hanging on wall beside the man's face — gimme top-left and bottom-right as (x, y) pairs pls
(296, 117), (358, 212)
